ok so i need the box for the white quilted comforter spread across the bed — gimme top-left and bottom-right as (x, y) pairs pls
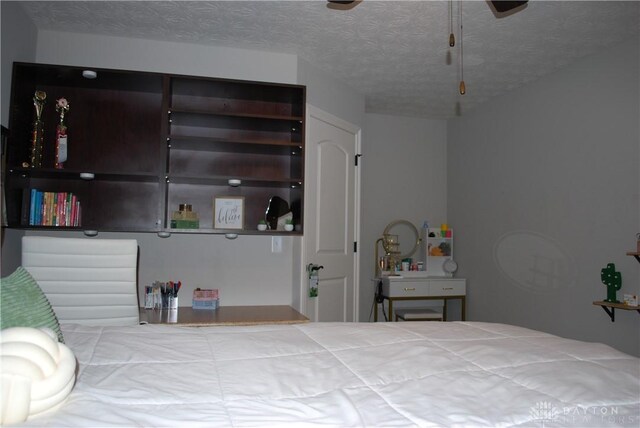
(21, 322), (640, 427)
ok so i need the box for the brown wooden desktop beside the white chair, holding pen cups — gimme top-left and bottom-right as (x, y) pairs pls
(140, 305), (309, 327)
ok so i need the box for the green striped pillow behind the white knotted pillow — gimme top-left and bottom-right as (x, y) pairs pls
(0, 266), (64, 343)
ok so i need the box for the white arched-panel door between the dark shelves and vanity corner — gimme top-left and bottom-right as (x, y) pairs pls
(301, 106), (360, 321)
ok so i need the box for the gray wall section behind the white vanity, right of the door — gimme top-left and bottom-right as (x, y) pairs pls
(360, 114), (448, 321)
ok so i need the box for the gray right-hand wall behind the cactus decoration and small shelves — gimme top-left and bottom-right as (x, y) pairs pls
(447, 38), (640, 355)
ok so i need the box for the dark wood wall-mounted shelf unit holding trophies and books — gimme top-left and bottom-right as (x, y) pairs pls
(6, 63), (305, 235)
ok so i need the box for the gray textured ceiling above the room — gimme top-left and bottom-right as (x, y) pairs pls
(17, 0), (640, 118)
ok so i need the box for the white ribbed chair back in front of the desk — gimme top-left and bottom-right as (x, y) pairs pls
(22, 236), (139, 325)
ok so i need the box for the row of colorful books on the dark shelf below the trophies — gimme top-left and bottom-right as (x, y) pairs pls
(23, 189), (82, 227)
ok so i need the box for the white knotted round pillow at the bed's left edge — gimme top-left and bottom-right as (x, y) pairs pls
(0, 327), (77, 425)
